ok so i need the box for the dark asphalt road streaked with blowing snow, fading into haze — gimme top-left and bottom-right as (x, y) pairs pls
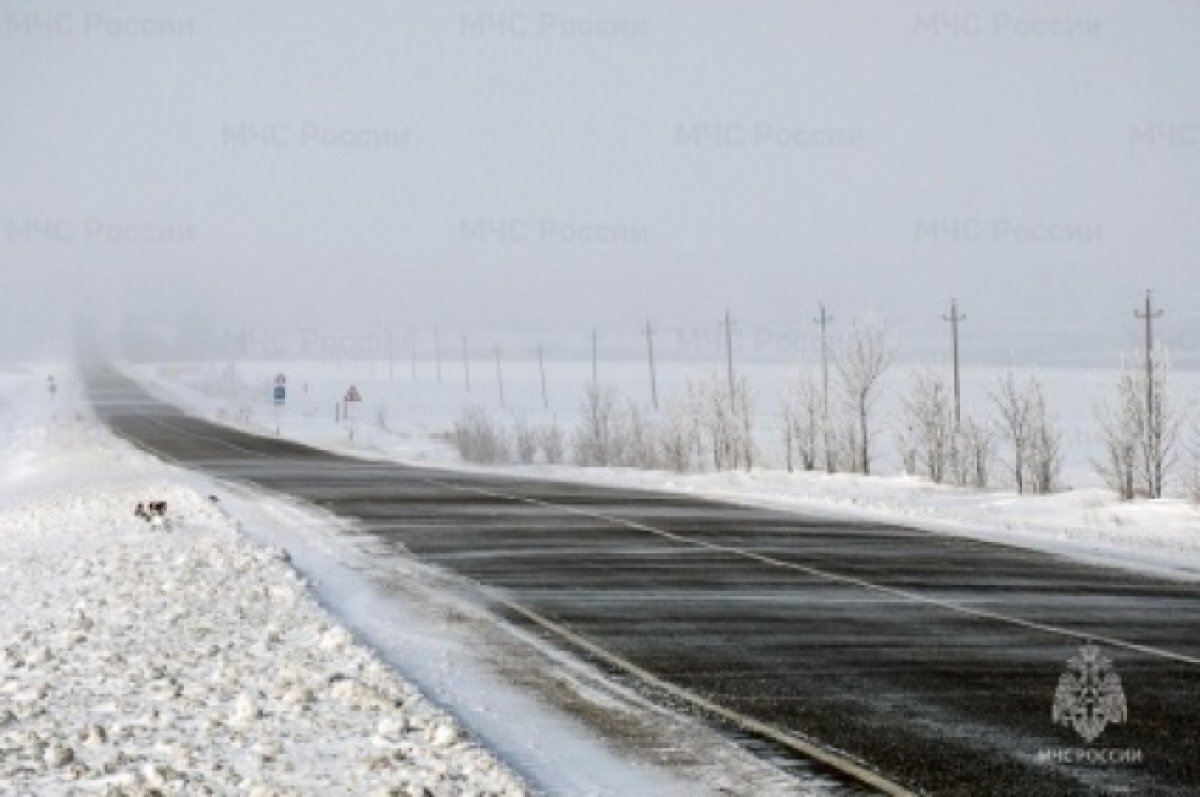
(90, 372), (1200, 795)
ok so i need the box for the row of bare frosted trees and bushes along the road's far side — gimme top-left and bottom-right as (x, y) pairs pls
(452, 317), (1200, 498)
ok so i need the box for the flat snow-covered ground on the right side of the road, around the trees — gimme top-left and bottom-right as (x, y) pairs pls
(131, 361), (1200, 580)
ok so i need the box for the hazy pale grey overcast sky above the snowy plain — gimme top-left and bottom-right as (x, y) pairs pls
(0, 0), (1200, 359)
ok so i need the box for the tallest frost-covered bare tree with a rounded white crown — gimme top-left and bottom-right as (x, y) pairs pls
(834, 316), (895, 475)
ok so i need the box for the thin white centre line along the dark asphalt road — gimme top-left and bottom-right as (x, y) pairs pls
(426, 480), (1200, 666)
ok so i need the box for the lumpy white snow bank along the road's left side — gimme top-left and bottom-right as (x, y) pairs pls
(0, 374), (524, 795)
